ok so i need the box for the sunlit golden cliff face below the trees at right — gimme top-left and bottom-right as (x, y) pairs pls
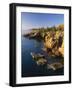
(44, 31), (64, 56)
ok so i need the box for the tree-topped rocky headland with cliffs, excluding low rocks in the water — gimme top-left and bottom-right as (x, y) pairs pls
(24, 24), (64, 57)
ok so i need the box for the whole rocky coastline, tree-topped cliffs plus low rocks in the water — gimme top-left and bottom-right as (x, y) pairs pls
(24, 24), (64, 70)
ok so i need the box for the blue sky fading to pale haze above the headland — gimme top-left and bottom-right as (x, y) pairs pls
(21, 12), (64, 30)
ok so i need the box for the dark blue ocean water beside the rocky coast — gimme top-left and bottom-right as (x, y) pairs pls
(21, 36), (64, 77)
